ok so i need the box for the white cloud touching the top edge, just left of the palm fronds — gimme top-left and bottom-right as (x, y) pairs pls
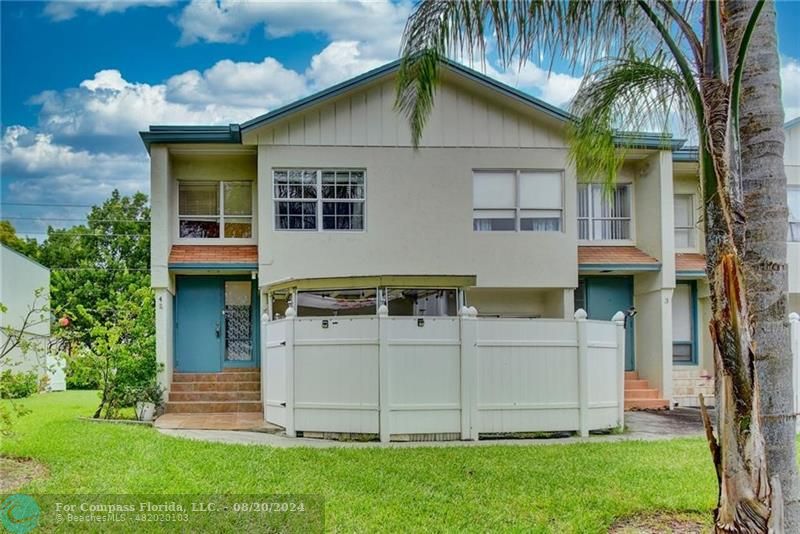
(176, 0), (411, 60)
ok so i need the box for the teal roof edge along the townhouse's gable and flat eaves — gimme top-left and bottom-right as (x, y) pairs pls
(139, 59), (685, 152)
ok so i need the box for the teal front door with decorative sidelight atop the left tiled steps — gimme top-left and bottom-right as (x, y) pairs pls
(175, 276), (258, 373)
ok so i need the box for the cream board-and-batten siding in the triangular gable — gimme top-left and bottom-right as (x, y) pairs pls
(253, 80), (565, 148)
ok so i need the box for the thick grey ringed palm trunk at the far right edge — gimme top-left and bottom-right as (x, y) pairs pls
(727, 0), (800, 532)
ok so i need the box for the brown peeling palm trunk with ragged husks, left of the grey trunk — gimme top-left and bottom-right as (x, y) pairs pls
(698, 6), (780, 533)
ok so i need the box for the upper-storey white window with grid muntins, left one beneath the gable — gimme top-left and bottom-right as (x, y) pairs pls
(272, 169), (366, 231)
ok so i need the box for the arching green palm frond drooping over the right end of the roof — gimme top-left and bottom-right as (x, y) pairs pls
(568, 52), (694, 186)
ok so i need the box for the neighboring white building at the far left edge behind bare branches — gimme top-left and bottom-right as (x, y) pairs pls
(0, 245), (66, 391)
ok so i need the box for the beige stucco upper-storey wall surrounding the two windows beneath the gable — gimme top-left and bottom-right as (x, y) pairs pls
(259, 146), (578, 288)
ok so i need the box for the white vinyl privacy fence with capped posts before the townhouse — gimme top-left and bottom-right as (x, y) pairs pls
(262, 307), (625, 441)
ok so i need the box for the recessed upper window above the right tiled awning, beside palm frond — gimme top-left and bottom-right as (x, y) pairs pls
(578, 184), (631, 241)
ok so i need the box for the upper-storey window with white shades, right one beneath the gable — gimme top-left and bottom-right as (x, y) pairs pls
(472, 170), (564, 232)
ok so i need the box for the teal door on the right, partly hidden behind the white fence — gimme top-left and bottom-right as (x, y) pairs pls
(578, 276), (636, 371)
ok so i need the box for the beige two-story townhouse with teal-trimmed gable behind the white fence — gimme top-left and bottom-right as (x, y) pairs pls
(141, 62), (702, 428)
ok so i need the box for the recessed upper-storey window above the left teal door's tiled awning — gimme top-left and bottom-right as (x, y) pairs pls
(178, 180), (253, 239)
